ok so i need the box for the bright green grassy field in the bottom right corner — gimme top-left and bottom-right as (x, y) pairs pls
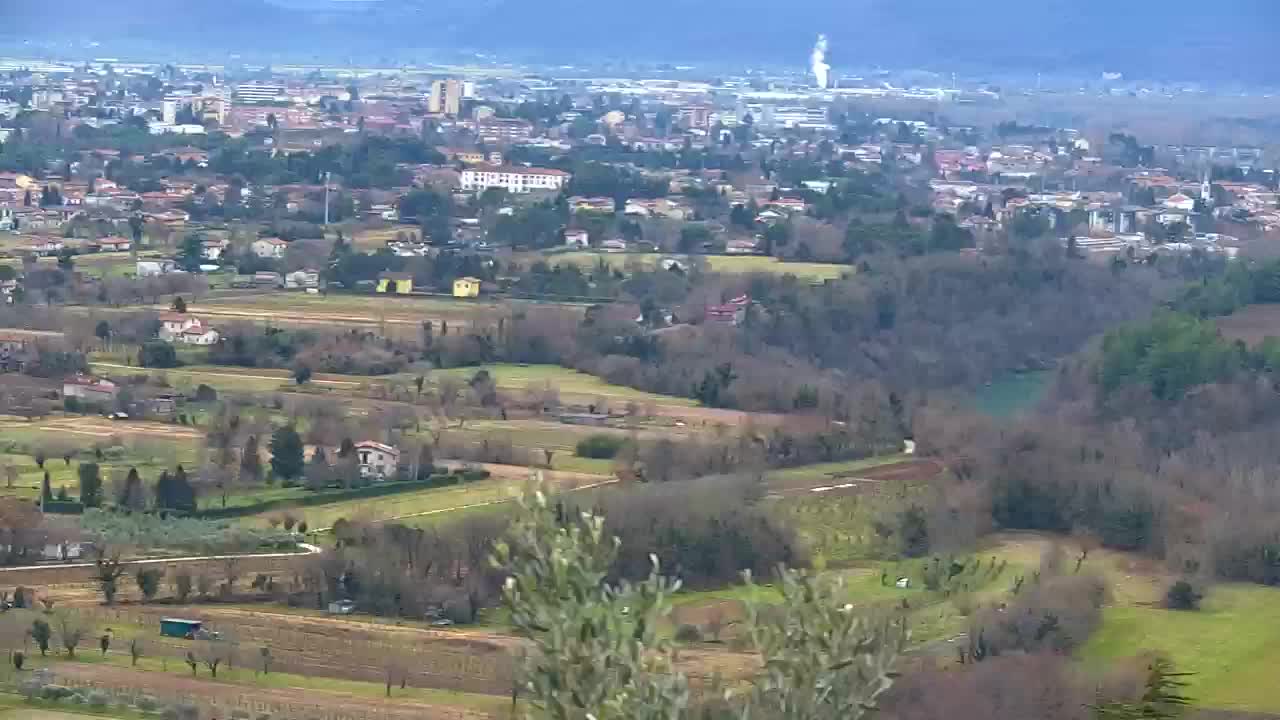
(1082, 584), (1280, 712)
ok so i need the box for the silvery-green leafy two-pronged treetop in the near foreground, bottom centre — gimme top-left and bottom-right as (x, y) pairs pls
(494, 484), (906, 720)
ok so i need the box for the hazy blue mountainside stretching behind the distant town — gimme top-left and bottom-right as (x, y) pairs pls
(0, 0), (1280, 83)
